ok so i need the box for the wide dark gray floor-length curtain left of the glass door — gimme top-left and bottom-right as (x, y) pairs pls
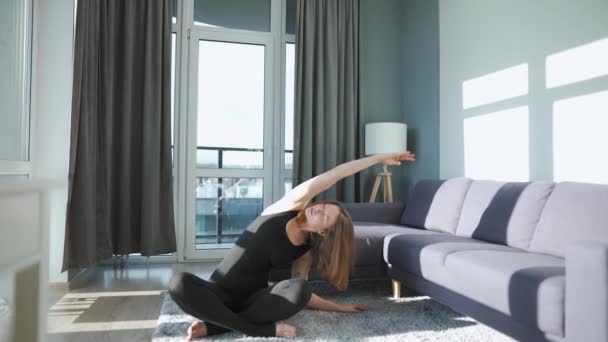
(62, 0), (176, 271)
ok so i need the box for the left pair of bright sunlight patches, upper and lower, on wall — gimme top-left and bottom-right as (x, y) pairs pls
(462, 63), (530, 181)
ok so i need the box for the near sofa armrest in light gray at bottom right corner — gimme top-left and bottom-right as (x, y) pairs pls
(565, 241), (608, 342)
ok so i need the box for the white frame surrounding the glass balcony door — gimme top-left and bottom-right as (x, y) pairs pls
(176, 0), (295, 261)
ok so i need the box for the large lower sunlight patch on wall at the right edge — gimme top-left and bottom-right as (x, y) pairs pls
(553, 91), (608, 183)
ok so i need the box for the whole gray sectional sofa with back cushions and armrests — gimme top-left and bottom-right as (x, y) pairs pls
(347, 178), (608, 342)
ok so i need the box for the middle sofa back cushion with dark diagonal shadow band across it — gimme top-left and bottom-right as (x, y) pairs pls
(456, 180), (555, 249)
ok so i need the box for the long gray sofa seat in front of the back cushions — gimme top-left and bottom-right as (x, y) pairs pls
(384, 234), (565, 336)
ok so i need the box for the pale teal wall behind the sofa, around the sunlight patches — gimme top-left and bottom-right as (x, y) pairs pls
(439, 0), (608, 180)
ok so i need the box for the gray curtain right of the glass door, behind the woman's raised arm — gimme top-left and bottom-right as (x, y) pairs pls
(294, 0), (363, 202)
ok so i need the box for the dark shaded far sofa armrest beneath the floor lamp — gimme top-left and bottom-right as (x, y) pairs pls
(344, 202), (405, 224)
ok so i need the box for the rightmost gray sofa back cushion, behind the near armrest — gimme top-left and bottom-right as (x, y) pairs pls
(530, 182), (608, 257)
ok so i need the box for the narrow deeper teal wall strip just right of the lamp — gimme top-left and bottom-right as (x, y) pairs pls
(401, 0), (439, 199)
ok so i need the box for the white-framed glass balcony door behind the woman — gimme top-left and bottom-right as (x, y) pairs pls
(184, 32), (274, 259)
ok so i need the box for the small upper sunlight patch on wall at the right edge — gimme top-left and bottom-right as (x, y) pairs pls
(546, 39), (608, 88)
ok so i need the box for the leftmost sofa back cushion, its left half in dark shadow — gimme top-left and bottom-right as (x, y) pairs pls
(401, 178), (471, 234)
